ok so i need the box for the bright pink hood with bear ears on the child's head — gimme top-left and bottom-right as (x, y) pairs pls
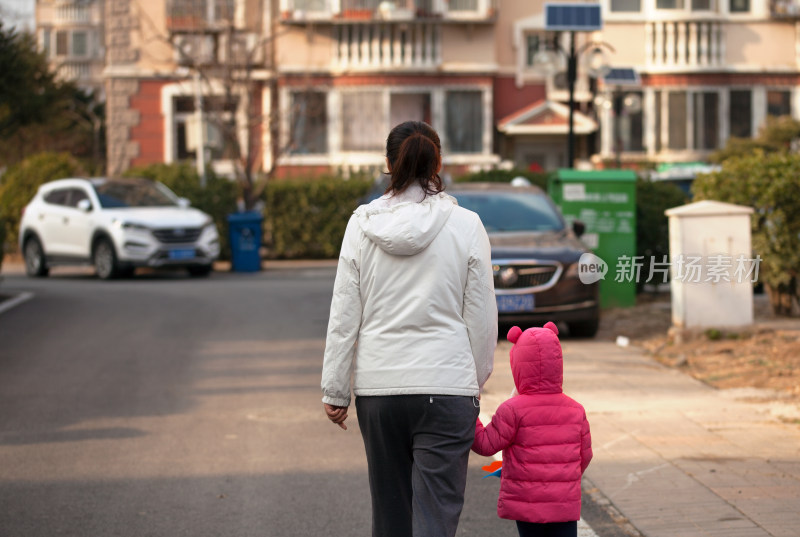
(508, 322), (564, 395)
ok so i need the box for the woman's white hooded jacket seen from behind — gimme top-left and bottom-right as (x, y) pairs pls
(322, 186), (497, 406)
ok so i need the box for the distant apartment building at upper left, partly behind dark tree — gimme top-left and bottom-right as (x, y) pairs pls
(35, 0), (105, 96)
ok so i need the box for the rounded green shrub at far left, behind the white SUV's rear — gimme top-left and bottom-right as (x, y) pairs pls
(0, 153), (83, 248)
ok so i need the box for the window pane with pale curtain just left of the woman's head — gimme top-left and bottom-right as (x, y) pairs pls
(342, 91), (387, 151)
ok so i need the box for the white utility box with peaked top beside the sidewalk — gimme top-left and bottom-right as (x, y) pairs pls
(666, 201), (759, 329)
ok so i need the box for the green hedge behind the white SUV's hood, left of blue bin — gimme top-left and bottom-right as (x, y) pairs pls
(125, 163), (239, 259)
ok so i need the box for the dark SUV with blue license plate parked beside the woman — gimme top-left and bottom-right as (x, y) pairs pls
(446, 183), (600, 337)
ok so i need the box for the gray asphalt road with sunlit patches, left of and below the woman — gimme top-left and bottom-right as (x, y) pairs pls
(0, 268), (621, 537)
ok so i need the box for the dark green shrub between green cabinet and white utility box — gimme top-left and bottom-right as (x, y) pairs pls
(636, 178), (688, 291)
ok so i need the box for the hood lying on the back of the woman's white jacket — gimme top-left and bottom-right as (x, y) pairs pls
(355, 187), (458, 255)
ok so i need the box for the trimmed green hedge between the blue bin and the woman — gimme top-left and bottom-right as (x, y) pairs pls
(265, 177), (373, 258)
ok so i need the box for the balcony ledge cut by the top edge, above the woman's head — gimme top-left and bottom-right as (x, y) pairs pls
(280, 0), (496, 23)
